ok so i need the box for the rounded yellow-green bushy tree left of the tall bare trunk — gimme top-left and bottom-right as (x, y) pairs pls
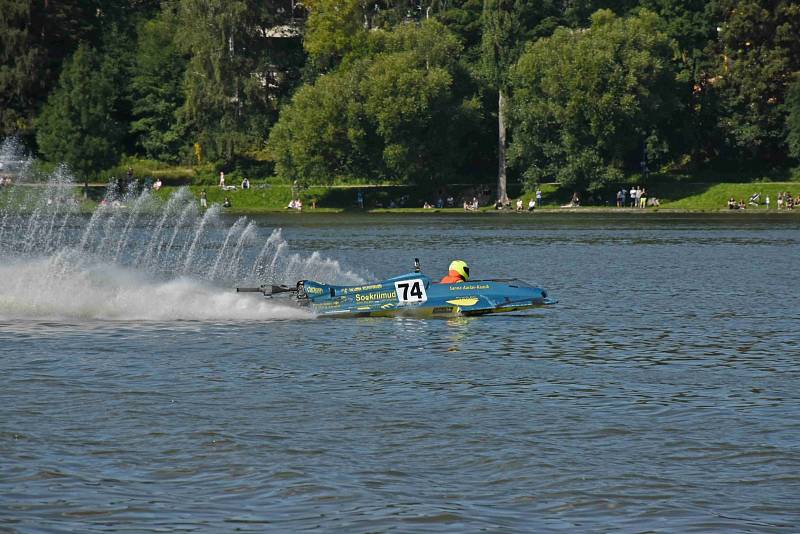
(269, 19), (481, 183)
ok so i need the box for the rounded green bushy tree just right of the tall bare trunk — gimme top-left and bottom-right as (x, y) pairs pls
(510, 10), (678, 190)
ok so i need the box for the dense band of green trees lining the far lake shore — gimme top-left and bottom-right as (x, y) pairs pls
(0, 0), (800, 197)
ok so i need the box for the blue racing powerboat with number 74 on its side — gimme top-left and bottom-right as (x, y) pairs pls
(236, 259), (557, 317)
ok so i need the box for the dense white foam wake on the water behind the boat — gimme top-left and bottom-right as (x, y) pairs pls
(0, 253), (313, 322)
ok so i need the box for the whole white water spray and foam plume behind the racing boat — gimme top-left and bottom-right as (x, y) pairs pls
(0, 140), (363, 320)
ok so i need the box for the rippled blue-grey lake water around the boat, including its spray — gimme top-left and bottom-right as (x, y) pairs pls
(0, 206), (800, 532)
